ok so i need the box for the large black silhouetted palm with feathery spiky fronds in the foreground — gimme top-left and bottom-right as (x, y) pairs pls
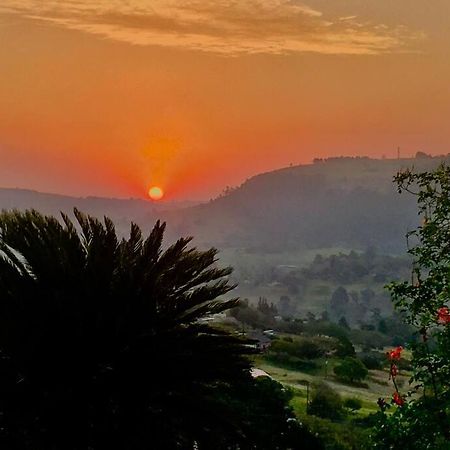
(0, 210), (320, 450)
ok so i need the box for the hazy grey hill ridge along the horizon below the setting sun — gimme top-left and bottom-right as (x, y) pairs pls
(0, 154), (446, 253)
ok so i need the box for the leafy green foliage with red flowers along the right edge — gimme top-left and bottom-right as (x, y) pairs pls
(376, 164), (450, 450)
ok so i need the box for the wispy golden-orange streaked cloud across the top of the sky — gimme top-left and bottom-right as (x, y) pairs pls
(0, 0), (423, 56)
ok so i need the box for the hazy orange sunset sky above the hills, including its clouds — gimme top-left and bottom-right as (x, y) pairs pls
(0, 0), (450, 199)
